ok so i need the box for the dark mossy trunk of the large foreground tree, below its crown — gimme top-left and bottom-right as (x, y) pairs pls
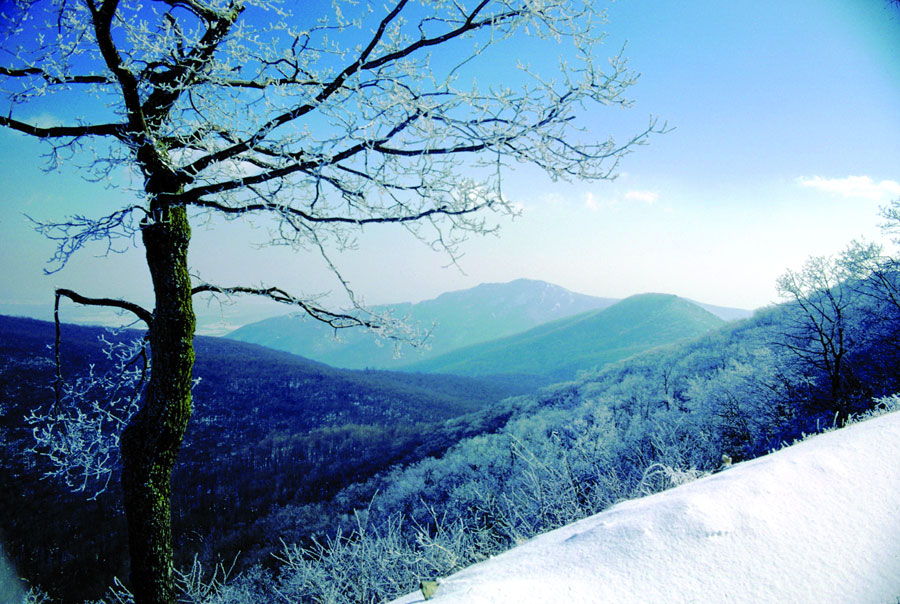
(121, 206), (195, 604)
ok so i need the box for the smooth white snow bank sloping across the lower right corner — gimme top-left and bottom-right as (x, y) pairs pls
(394, 412), (900, 604)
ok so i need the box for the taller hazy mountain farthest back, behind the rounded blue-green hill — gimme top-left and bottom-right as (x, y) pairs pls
(226, 279), (616, 369)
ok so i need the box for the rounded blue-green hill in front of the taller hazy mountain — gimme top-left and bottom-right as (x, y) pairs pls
(409, 294), (724, 382)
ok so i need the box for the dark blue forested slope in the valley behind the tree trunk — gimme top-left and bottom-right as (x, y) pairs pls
(0, 316), (515, 601)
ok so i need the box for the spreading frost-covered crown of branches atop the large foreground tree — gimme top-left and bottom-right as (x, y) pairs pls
(0, 0), (666, 330)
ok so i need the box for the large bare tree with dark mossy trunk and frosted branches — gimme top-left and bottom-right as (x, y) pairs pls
(0, 0), (663, 604)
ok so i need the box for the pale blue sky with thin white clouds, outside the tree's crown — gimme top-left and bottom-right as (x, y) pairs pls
(0, 0), (900, 331)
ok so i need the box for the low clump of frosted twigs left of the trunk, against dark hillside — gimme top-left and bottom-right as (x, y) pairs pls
(25, 336), (150, 499)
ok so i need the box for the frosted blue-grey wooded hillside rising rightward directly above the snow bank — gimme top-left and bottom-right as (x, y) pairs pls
(137, 263), (900, 603)
